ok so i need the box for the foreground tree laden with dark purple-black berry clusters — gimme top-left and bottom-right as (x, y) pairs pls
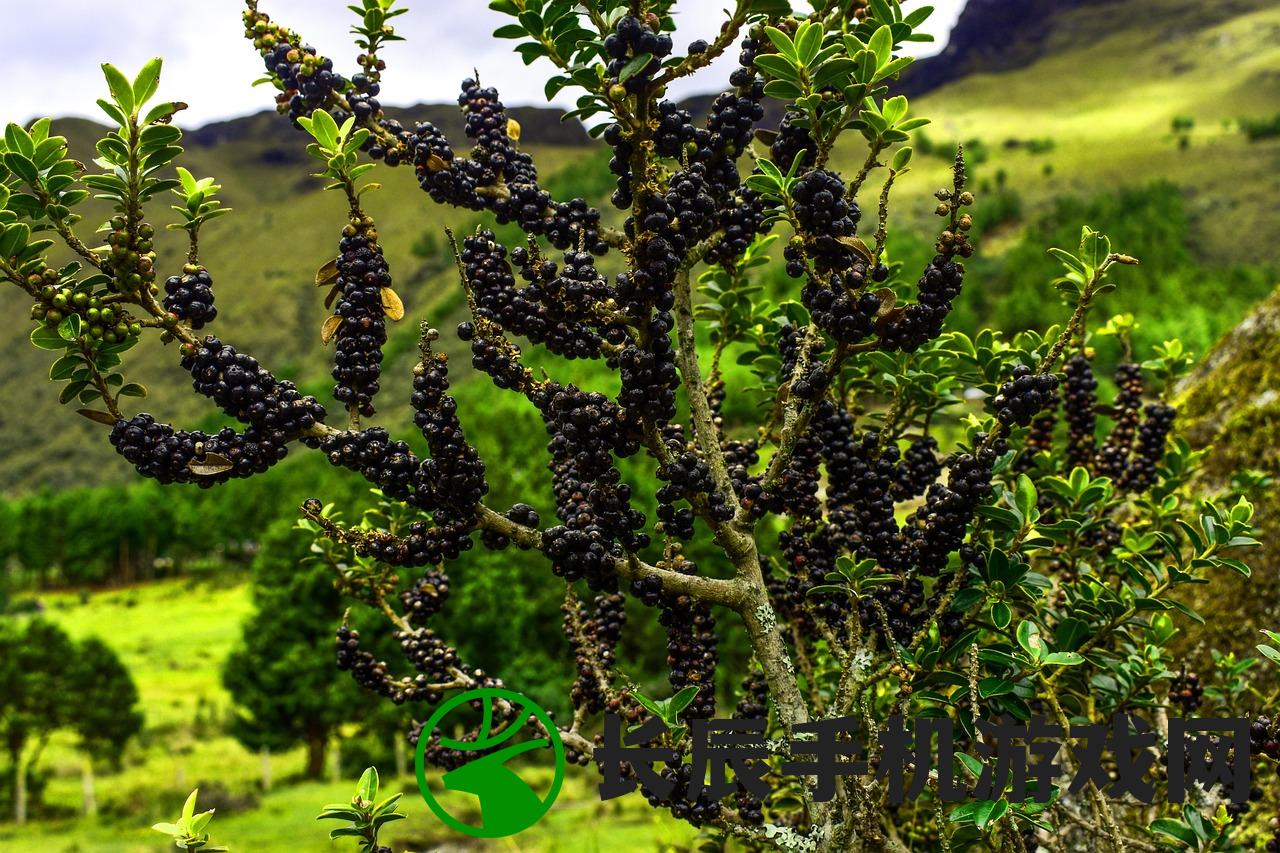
(0, 0), (1264, 850)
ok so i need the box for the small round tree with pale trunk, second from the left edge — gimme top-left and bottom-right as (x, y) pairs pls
(67, 637), (145, 815)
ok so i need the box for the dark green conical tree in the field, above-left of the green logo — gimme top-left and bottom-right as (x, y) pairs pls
(223, 520), (358, 779)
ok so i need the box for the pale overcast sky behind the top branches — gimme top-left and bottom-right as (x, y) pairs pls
(0, 0), (965, 127)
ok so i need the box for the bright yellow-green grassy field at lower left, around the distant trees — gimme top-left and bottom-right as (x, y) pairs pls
(0, 580), (690, 853)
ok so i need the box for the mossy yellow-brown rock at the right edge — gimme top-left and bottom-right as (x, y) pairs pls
(1175, 288), (1280, 666)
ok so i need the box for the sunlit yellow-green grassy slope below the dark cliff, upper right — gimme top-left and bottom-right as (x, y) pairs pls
(837, 0), (1280, 263)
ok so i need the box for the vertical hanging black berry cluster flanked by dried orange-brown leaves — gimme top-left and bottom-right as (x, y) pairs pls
(333, 216), (392, 415)
